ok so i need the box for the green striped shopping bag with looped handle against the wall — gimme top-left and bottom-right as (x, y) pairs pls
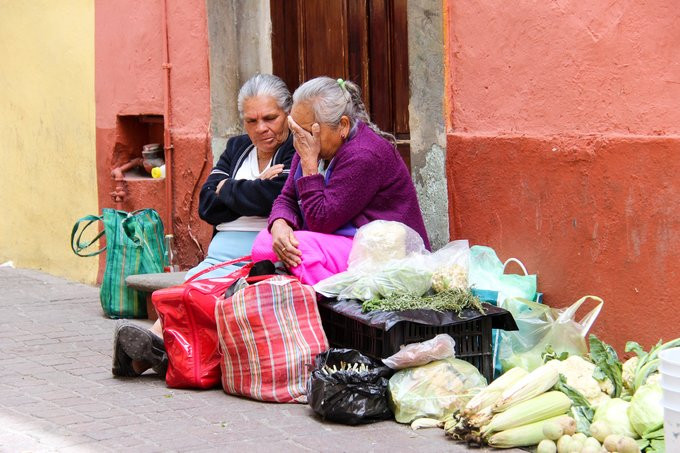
(71, 208), (166, 318)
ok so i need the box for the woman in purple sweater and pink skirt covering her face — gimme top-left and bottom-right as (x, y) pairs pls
(252, 77), (429, 285)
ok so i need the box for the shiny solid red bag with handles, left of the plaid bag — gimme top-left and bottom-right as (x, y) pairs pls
(151, 256), (253, 389)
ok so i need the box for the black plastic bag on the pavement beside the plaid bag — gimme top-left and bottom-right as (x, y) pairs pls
(307, 349), (394, 425)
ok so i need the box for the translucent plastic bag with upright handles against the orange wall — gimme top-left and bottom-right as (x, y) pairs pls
(498, 296), (604, 371)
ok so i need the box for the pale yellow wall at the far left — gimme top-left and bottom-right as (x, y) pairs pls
(0, 0), (98, 283)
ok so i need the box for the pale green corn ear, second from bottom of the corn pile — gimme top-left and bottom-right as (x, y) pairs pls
(482, 391), (571, 437)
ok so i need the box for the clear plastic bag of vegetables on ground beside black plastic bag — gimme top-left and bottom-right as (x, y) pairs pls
(389, 358), (486, 423)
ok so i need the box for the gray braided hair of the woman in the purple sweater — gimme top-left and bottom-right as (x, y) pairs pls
(293, 76), (396, 144)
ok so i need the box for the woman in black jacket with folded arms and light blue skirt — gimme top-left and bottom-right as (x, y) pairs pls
(112, 74), (295, 377)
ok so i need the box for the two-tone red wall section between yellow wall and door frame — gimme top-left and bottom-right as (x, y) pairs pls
(95, 0), (212, 269)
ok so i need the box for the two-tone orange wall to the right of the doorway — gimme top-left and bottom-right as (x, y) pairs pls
(445, 0), (680, 351)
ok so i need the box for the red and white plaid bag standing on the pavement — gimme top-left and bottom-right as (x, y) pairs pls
(215, 276), (328, 403)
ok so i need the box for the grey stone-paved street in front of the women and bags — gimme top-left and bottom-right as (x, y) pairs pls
(0, 268), (508, 453)
